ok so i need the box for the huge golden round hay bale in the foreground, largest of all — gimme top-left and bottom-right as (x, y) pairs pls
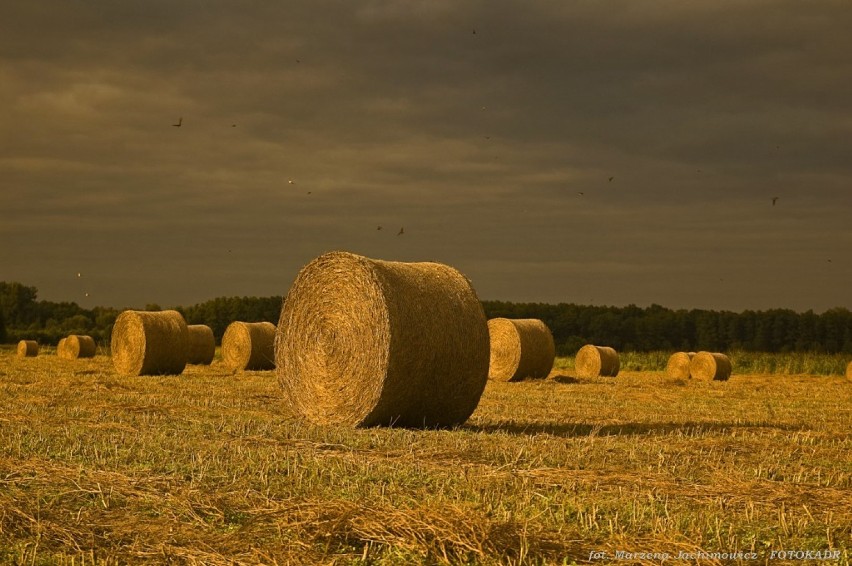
(275, 252), (489, 427)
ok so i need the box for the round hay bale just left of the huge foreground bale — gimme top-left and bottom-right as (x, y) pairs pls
(222, 321), (275, 371)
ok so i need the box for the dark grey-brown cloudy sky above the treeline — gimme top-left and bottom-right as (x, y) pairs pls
(0, 0), (852, 312)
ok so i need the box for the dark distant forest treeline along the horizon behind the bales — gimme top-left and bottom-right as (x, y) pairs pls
(0, 282), (852, 356)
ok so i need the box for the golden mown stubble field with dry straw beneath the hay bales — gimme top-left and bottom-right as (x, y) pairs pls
(0, 349), (852, 565)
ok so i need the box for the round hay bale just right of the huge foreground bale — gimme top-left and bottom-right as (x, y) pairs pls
(488, 318), (556, 381)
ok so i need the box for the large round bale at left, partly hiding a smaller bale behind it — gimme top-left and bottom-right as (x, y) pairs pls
(110, 310), (187, 375)
